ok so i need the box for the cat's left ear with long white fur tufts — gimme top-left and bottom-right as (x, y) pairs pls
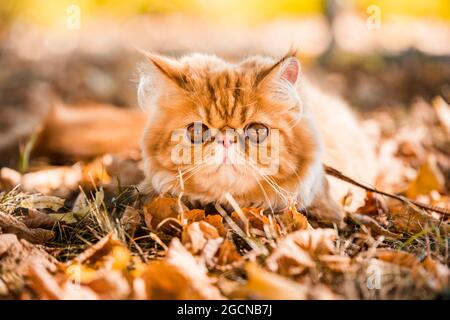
(138, 52), (186, 111)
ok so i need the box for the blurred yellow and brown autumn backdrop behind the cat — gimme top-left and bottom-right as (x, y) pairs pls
(0, 0), (450, 168)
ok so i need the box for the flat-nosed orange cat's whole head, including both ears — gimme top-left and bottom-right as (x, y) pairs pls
(139, 55), (317, 201)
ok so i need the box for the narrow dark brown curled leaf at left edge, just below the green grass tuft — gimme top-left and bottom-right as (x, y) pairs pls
(0, 212), (55, 244)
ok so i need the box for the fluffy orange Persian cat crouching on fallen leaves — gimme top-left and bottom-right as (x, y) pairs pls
(138, 52), (376, 224)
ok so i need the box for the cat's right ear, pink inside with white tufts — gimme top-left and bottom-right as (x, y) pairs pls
(256, 54), (300, 101)
